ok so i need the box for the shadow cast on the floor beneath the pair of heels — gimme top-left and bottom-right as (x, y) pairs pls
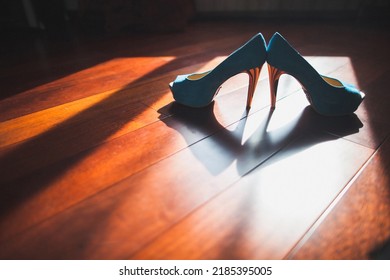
(159, 102), (363, 176)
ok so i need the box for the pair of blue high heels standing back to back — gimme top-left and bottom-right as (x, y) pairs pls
(169, 33), (364, 116)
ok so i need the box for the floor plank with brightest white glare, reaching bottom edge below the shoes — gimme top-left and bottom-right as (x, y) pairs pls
(133, 134), (372, 259)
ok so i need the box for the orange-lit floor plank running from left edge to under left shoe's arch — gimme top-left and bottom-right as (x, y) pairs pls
(1, 83), (292, 243)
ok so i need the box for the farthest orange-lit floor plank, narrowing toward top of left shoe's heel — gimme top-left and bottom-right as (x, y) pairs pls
(0, 31), (258, 121)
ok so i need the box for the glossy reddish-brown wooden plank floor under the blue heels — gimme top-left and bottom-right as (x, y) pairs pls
(0, 22), (390, 259)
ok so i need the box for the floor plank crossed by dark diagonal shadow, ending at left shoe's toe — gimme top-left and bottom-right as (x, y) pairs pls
(0, 58), (245, 179)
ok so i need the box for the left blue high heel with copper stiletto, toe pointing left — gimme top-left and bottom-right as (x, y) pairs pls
(169, 33), (267, 109)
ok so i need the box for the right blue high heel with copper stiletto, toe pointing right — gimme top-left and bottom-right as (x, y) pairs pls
(267, 33), (364, 116)
